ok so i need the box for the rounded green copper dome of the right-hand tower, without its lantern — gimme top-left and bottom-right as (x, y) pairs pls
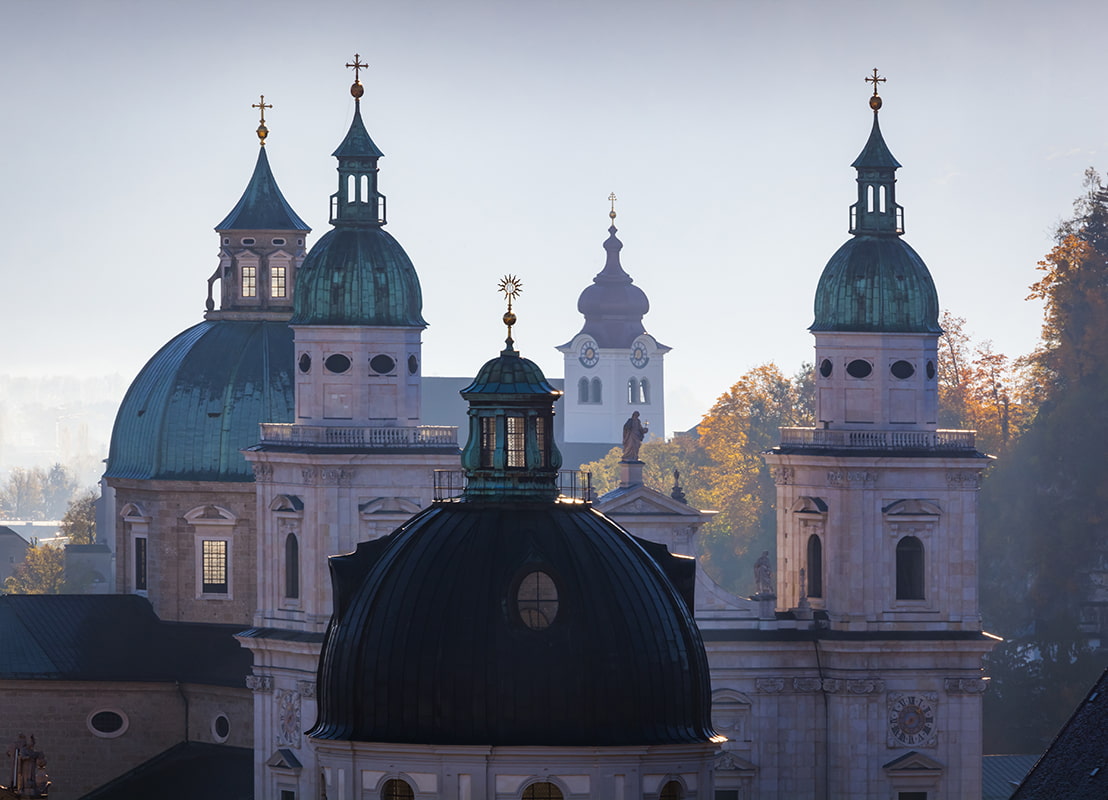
(810, 236), (942, 334)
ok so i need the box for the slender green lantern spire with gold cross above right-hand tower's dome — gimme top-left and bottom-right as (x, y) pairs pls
(850, 68), (904, 236)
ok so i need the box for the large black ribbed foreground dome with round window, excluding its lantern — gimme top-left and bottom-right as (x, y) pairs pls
(309, 502), (712, 747)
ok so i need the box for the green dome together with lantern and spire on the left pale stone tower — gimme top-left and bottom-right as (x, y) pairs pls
(291, 73), (427, 328)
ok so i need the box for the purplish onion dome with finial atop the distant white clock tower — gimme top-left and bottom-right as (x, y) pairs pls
(577, 208), (650, 348)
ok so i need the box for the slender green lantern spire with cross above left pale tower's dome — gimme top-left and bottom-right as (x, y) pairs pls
(331, 53), (387, 227)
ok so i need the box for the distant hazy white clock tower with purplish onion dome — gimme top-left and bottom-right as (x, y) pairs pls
(557, 195), (670, 466)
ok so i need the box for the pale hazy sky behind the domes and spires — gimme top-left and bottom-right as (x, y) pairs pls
(0, 0), (1108, 432)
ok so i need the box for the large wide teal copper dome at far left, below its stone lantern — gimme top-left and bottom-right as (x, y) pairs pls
(104, 320), (294, 481)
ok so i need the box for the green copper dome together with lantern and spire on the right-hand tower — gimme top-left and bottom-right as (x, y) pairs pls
(810, 79), (942, 334)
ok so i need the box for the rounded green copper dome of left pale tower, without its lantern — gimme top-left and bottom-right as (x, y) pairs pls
(293, 226), (427, 328)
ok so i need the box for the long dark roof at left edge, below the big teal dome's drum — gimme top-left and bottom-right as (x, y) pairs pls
(0, 595), (252, 686)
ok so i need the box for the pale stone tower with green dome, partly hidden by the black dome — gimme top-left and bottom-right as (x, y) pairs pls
(238, 57), (459, 800)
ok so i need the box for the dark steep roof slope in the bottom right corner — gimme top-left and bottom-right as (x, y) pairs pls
(1012, 669), (1108, 800)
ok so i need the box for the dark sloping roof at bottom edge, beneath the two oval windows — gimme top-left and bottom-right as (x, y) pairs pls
(81, 741), (254, 800)
